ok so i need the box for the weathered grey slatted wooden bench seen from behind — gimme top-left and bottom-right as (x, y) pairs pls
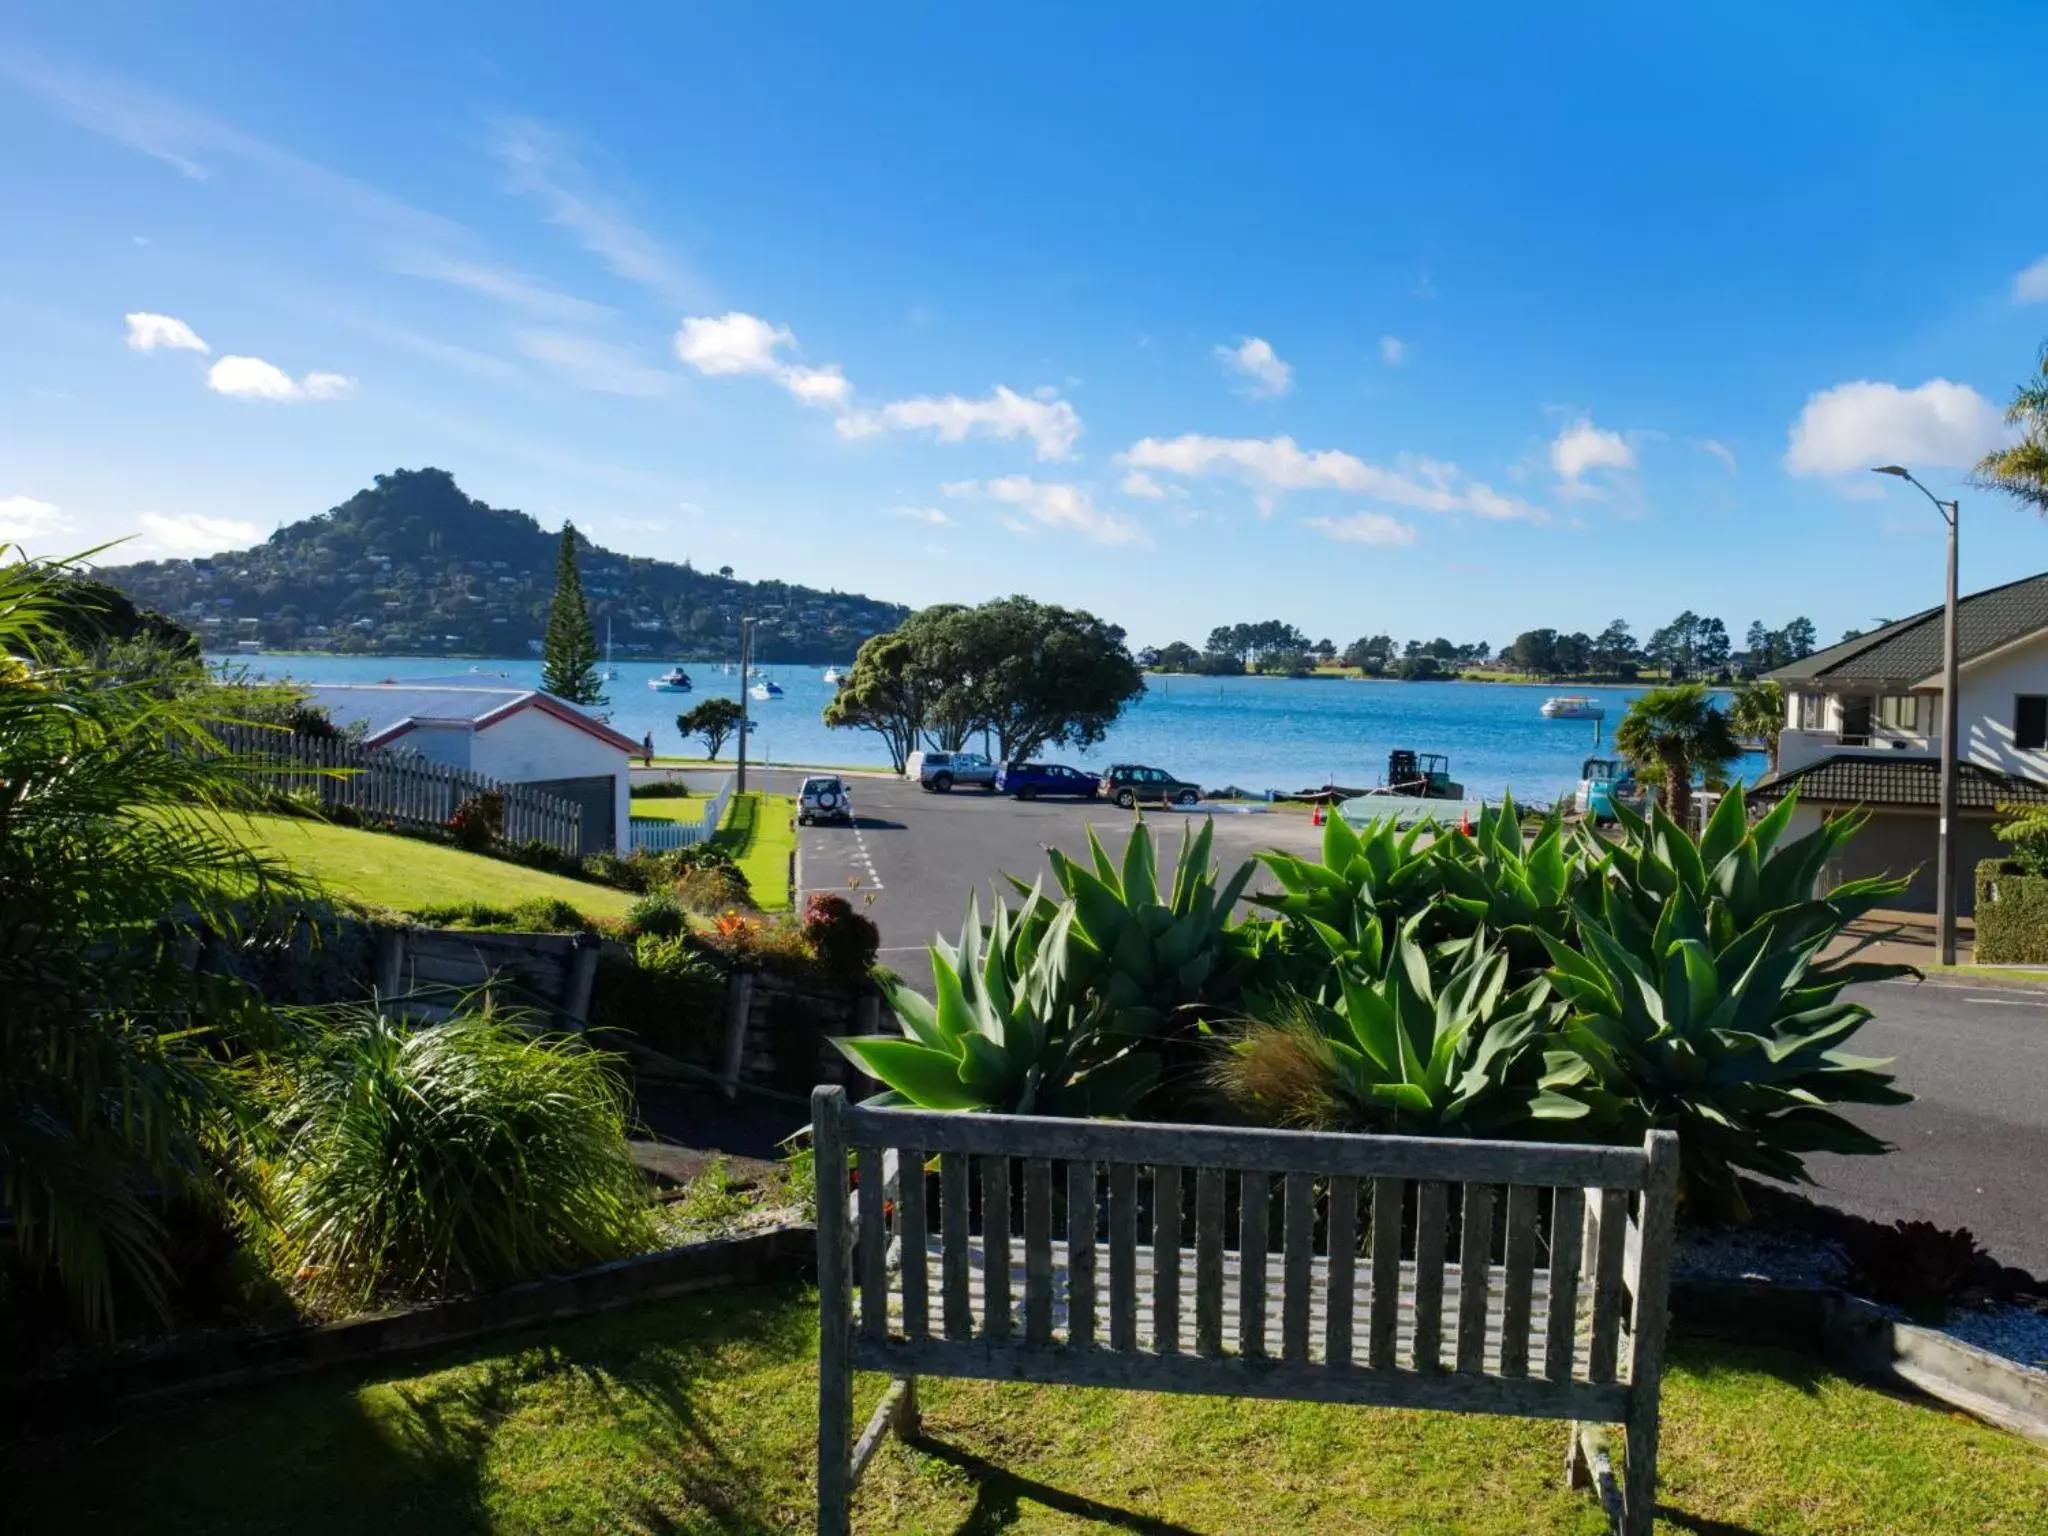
(811, 1087), (1677, 1536)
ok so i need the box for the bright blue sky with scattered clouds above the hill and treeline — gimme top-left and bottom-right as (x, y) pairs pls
(0, 0), (2048, 645)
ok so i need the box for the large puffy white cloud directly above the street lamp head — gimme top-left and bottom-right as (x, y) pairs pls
(1786, 379), (2003, 475)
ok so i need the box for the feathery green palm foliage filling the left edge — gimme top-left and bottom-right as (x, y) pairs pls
(0, 545), (291, 1329)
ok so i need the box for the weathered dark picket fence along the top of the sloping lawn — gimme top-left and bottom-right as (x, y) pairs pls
(213, 723), (584, 856)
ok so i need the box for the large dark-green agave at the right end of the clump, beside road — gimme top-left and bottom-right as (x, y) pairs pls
(1544, 791), (1911, 1219)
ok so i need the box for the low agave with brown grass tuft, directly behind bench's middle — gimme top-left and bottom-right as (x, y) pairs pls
(1214, 934), (1589, 1137)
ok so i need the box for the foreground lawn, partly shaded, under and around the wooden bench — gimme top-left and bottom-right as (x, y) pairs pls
(0, 1286), (2048, 1536)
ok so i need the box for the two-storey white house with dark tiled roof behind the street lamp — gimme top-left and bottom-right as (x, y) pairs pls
(1755, 573), (2048, 915)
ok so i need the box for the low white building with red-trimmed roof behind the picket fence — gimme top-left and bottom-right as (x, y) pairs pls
(307, 682), (639, 854)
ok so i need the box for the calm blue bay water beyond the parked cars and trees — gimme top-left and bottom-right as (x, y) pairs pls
(238, 655), (1763, 805)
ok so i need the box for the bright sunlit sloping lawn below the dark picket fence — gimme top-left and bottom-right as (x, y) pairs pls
(234, 815), (633, 918)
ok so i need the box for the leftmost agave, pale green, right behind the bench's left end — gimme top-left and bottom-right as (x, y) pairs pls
(834, 889), (1159, 1116)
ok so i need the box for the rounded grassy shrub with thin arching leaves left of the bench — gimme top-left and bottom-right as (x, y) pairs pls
(262, 1010), (651, 1309)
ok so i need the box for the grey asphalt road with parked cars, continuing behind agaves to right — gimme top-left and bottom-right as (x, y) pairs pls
(770, 770), (2048, 1276)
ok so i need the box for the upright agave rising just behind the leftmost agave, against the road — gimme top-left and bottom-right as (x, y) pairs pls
(1032, 821), (1253, 1034)
